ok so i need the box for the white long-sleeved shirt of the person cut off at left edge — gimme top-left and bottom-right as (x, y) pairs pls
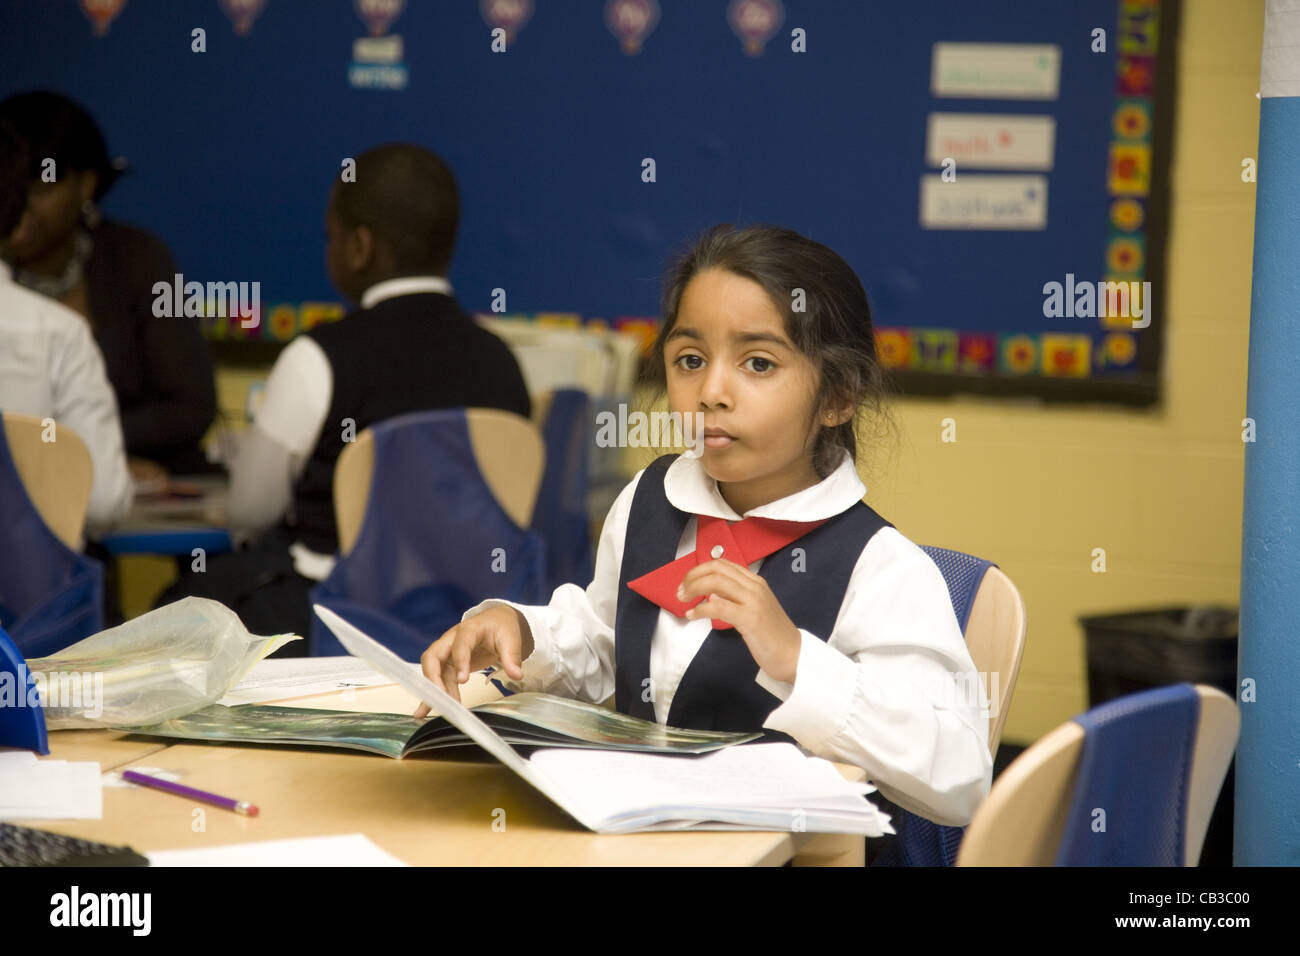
(0, 263), (134, 537)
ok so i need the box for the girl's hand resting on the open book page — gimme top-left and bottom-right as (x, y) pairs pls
(415, 605), (533, 718)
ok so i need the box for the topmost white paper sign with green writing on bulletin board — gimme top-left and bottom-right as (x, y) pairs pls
(930, 43), (1061, 100)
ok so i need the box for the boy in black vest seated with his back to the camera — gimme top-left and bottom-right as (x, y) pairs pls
(159, 143), (532, 656)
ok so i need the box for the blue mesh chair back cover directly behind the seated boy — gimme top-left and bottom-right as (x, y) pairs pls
(311, 408), (546, 661)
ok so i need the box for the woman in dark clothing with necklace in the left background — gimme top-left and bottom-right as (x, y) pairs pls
(0, 91), (217, 481)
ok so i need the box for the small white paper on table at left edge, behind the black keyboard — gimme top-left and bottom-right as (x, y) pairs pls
(0, 750), (104, 821)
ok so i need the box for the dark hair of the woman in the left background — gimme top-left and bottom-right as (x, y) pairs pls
(0, 90), (122, 202)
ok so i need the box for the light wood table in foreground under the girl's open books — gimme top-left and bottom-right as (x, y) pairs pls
(34, 683), (865, 866)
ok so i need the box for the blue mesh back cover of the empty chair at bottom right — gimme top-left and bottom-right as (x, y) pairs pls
(1057, 684), (1201, 866)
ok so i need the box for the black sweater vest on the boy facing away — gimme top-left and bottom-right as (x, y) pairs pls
(291, 293), (532, 554)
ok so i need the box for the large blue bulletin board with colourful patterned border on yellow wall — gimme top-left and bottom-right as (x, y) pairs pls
(0, 0), (1177, 405)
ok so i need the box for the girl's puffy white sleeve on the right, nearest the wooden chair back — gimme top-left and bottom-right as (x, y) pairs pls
(755, 528), (993, 826)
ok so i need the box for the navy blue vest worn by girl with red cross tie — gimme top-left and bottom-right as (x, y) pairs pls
(614, 455), (893, 740)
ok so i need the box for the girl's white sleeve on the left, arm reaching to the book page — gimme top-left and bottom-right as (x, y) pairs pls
(460, 472), (644, 704)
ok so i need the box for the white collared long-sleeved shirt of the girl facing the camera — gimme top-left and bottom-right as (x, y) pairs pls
(464, 455), (993, 826)
